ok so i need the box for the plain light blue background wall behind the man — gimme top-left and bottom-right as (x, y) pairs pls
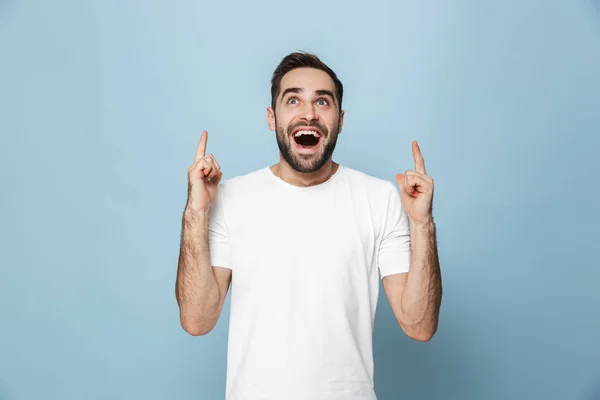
(0, 0), (600, 400)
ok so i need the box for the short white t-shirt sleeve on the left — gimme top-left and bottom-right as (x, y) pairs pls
(208, 186), (231, 269)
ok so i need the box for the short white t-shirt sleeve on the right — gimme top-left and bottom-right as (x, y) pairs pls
(378, 182), (410, 279)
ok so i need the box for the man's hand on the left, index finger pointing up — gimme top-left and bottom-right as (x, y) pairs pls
(186, 131), (223, 213)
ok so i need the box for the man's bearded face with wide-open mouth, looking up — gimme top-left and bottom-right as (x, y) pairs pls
(267, 68), (344, 173)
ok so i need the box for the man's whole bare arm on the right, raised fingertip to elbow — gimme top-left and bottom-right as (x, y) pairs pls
(382, 142), (442, 341)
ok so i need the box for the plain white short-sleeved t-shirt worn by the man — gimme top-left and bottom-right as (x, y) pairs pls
(209, 165), (410, 400)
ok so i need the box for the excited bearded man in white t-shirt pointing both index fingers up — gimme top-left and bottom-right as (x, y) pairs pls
(176, 53), (442, 400)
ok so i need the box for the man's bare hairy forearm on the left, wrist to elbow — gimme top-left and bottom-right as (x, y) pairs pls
(175, 211), (220, 333)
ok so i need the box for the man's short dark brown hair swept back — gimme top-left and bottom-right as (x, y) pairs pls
(271, 51), (344, 111)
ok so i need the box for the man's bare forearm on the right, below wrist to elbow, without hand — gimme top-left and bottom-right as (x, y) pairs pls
(401, 221), (442, 340)
